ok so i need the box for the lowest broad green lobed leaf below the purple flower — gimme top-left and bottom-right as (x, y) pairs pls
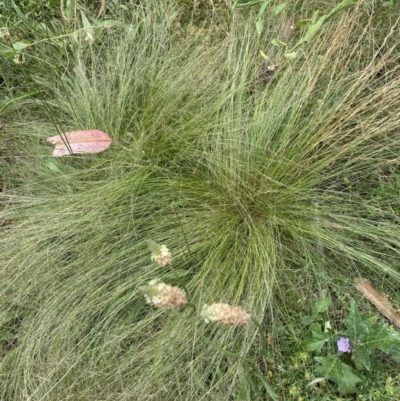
(314, 356), (362, 395)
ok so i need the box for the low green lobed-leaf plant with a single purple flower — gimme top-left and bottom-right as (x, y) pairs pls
(302, 296), (400, 394)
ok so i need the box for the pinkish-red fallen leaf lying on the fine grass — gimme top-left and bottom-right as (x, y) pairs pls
(47, 130), (112, 156)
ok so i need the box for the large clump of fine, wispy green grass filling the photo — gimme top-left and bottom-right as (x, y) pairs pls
(0, 3), (400, 401)
